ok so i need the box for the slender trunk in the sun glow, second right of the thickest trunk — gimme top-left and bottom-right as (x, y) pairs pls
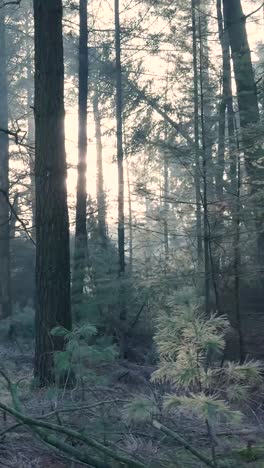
(93, 91), (107, 245)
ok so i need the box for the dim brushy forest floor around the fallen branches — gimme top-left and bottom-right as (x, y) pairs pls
(0, 343), (264, 468)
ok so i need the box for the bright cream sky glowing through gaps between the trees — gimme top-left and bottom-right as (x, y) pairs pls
(65, 0), (264, 227)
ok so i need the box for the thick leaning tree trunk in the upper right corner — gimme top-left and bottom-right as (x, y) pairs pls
(223, 0), (264, 269)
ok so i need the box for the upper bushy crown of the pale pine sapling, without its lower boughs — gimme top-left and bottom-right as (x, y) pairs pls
(153, 293), (228, 389)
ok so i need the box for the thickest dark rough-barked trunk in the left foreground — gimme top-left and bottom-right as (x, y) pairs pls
(34, 0), (72, 385)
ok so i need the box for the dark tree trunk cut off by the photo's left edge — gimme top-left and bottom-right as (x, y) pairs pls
(0, 8), (12, 318)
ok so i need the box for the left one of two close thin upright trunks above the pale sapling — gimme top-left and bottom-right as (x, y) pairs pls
(192, 0), (203, 272)
